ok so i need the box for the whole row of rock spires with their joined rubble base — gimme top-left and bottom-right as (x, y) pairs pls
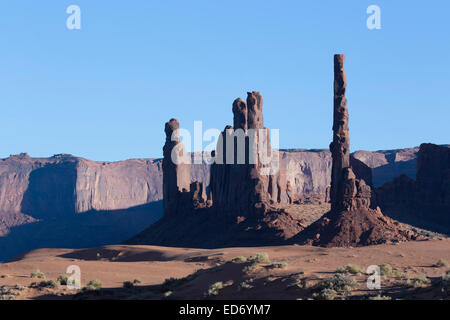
(128, 55), (417, 247)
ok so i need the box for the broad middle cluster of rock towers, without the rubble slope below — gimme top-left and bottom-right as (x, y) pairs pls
(210, 91), (288, 216)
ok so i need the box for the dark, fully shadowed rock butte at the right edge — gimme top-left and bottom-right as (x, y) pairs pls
(376, 143), (450, 234)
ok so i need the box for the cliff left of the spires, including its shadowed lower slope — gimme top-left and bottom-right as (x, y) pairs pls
(0, 154), (162, 261)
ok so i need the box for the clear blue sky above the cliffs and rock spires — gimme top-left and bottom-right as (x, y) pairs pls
(0, 0), (450, 161)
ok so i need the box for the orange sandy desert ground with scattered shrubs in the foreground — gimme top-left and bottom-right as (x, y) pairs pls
(0, 239), (450, 299)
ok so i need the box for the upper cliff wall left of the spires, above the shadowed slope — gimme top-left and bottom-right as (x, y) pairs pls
(0, 155), (162, 218)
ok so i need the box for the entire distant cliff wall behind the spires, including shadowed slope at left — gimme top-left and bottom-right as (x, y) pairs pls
(0, 148), (417, 261)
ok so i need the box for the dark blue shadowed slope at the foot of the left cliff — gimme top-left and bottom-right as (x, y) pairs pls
(0, 201), (163, 261)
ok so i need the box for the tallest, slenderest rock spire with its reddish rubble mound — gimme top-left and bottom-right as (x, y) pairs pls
(298, 54), (417, 246)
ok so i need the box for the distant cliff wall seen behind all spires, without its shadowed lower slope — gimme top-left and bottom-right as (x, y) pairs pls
(0, 148), (418, 233)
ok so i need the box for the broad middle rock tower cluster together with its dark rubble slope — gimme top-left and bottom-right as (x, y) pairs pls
(126, 92), (304, 248)
